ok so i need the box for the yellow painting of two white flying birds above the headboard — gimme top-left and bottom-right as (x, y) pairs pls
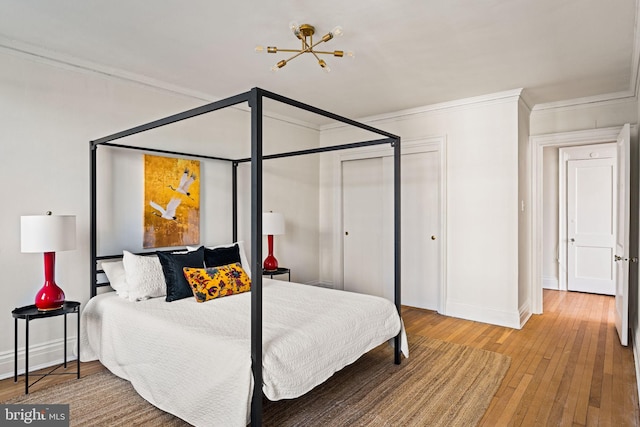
(142, 154), (200, 248)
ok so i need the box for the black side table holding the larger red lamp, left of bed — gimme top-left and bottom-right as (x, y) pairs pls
(11, 301), (80, 394)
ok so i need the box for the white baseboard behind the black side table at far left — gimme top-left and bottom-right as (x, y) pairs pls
(0, 336), (77, 379)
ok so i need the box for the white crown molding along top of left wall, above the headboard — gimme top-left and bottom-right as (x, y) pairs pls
(0, 35), (320, 131)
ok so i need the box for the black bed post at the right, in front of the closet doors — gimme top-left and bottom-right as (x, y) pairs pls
(392, 137), (402, 365)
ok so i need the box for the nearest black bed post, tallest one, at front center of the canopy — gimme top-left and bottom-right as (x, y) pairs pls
(249, 88), (262, 427)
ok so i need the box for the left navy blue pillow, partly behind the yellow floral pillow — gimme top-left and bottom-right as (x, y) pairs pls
(157, 248), (204, 302)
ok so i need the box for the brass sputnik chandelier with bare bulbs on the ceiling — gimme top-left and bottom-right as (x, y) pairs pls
(256, 22), (354, 72)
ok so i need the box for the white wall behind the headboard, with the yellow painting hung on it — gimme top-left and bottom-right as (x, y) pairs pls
(0, 51), (319, 377)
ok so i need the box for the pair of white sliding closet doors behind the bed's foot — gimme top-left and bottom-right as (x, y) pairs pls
(342, 151), (442, 310)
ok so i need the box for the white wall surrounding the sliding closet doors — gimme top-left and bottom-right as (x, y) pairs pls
(320, 91), (520, 327)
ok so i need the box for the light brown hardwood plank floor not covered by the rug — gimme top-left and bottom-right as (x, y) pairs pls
(0, 291), (640, 426)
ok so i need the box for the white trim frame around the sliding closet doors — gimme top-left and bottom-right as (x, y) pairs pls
(333, 136), (448, 314)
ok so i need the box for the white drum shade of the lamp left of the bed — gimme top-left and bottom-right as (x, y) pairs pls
(20, 215), (76, 252)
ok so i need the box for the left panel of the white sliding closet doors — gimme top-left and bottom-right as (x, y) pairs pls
(342, 157), (384, 296)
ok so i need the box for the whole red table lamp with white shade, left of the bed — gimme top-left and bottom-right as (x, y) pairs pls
(20, 212), (76, 311)
